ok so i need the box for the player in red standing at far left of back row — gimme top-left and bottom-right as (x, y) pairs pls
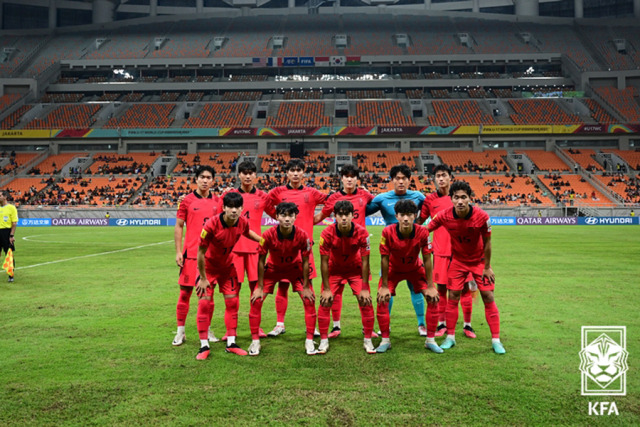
(173, 166), (222, 346)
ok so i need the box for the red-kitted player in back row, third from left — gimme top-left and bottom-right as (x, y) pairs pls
(265, 159), (327, 337)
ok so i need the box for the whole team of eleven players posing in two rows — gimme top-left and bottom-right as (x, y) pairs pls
(172, 158), (506, 360)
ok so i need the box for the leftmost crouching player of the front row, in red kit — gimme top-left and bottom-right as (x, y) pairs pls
(196, 192), (260, 360)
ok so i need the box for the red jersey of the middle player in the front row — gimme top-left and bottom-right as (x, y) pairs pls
(320, 222), (371, 272)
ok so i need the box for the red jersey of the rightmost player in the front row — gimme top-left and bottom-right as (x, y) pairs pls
(427, 206), (491, 264)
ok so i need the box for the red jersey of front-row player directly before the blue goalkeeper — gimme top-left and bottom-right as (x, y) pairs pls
(380, 224), (431, 273)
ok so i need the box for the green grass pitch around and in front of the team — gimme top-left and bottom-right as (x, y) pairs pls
(0, 226), (640, 426)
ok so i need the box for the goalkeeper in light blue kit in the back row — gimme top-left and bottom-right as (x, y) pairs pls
(367, 165), (427, 337)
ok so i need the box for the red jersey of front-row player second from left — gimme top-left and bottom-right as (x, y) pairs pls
(258, 225), (312, 270)
